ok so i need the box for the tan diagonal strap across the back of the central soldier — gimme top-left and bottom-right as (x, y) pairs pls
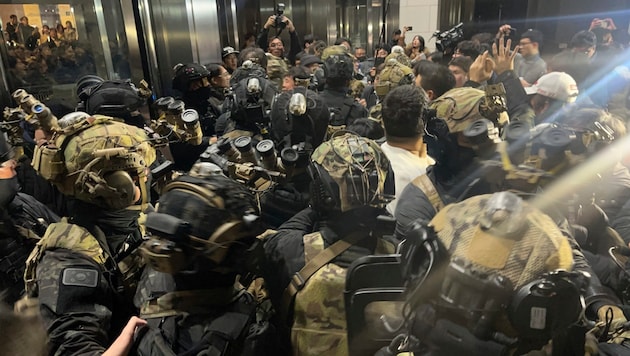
(282, 230), (368, 316)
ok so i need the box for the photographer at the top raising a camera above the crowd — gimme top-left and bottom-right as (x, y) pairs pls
(256, 4), (302, 65)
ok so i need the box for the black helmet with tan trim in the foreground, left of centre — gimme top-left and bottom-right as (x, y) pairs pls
(141, 163), (261, 274)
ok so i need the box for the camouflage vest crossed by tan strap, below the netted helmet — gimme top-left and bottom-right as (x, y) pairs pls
(291, 232), (394, 356)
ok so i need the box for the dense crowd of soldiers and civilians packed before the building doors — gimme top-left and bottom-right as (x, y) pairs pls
(0, 9), (630, 355)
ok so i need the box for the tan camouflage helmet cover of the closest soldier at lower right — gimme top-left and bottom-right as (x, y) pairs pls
(430, 192), (573, 290)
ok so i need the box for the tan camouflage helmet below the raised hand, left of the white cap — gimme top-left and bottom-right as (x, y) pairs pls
(429, 87), (508, 133)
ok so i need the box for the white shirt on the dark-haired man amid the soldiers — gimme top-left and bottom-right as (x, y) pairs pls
(381, 142), (435, 215)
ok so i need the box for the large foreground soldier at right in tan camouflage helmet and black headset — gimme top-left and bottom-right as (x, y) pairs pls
(389, 192), (590, 355)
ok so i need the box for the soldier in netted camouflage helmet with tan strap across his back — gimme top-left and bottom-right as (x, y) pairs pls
(263, 132), (393, 355)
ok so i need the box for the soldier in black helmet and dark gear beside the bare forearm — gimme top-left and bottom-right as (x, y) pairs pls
(136, 163), (276, 355)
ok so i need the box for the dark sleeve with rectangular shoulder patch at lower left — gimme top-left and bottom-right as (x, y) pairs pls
(36, 249), (113, 356)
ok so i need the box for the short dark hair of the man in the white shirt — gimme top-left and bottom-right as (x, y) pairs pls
(381, 84), (427, 139)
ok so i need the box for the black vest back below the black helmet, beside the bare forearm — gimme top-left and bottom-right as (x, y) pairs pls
(136, 287), (260, 356)
